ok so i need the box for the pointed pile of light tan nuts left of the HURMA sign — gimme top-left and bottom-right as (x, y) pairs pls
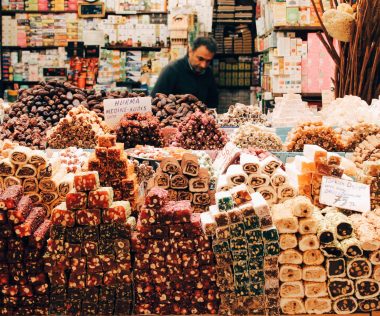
(48, 105), (110, 149)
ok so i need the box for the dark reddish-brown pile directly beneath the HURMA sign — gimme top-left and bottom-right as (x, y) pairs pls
(116, 113), (163, 148)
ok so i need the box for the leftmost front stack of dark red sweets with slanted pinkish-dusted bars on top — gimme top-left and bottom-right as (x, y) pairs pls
(0, 185), (51, 315)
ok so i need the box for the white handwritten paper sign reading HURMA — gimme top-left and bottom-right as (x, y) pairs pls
(103, 97), (152, 128)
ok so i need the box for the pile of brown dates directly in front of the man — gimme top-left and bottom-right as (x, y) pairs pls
(152, 93), (207, 127)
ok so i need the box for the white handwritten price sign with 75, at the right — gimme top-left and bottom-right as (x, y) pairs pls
(319, 177), (371, 212)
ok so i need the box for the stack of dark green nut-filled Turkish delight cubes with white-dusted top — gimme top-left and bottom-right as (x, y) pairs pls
(201, 184), (280, 315)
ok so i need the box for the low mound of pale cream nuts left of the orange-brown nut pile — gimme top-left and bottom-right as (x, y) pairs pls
(232, 123), (282, 151)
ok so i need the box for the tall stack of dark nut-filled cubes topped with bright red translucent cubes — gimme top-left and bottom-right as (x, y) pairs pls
(44, 172), (135, 315)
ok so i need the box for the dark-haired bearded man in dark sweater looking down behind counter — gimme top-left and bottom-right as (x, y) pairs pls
(152, 37), (218, 107)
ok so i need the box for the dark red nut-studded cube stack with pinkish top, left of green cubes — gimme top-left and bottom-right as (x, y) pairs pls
(132, 187), (218, 315)
